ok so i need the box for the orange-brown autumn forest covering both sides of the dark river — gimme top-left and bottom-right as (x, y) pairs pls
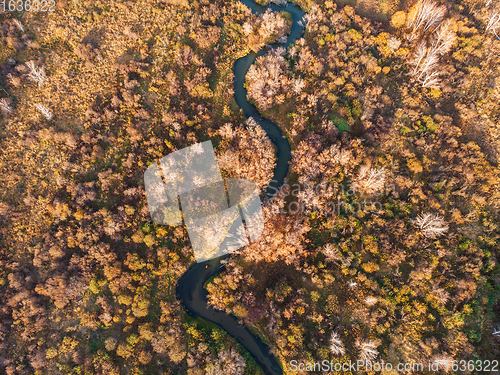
(0, 0), (500, 375)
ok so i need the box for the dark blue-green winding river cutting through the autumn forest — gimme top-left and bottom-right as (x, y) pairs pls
(176, 0), (305, 375)
